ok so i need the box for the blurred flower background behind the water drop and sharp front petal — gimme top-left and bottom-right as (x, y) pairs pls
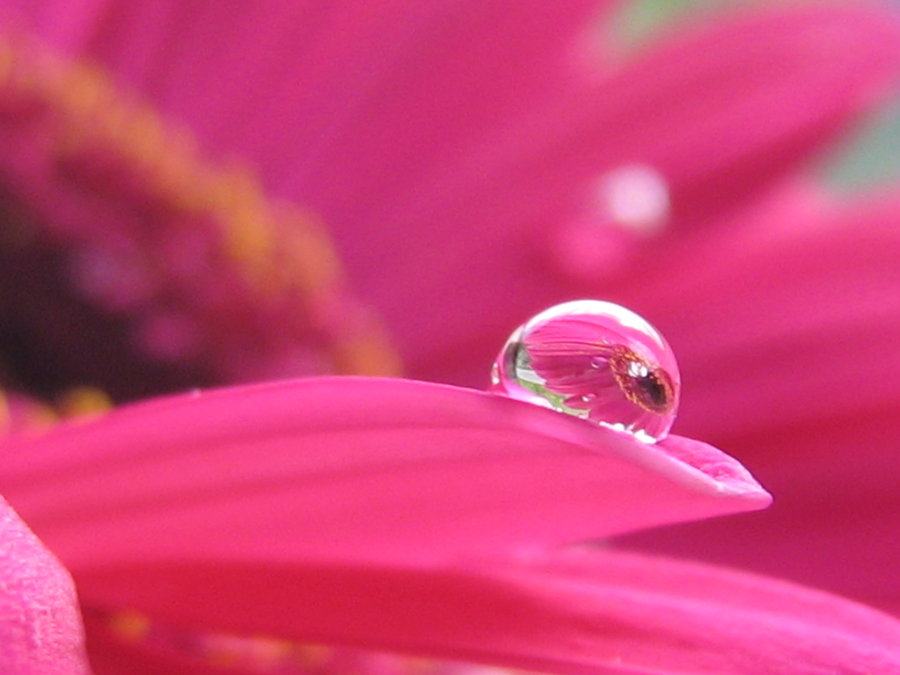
(0, 0), (900, 672)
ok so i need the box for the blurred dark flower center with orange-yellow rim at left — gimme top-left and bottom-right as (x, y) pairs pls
(0, 35), (399, 401)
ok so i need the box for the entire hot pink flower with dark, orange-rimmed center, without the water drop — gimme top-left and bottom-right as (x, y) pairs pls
(0, 0), (900, 673)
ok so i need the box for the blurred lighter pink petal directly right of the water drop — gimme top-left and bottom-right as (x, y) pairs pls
(640, 197), (900, 440)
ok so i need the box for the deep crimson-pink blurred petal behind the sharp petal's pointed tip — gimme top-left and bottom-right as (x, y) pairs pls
(618, 404), (900, 615)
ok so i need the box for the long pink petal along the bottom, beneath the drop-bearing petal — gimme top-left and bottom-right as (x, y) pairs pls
(74, 551), (900, 675)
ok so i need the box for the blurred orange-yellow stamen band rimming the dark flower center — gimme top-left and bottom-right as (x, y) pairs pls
(0, 37), (399, 374)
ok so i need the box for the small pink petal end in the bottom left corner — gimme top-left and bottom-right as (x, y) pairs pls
(0, 498), (88, 675)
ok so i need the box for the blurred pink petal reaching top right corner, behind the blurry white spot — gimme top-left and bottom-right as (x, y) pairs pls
(374, 3), (900, 382)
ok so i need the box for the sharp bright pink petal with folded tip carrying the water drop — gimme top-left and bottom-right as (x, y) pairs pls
(0, 378), (770, 570)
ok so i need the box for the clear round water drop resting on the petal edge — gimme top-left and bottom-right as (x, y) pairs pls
(491, 300), (681, 443)
